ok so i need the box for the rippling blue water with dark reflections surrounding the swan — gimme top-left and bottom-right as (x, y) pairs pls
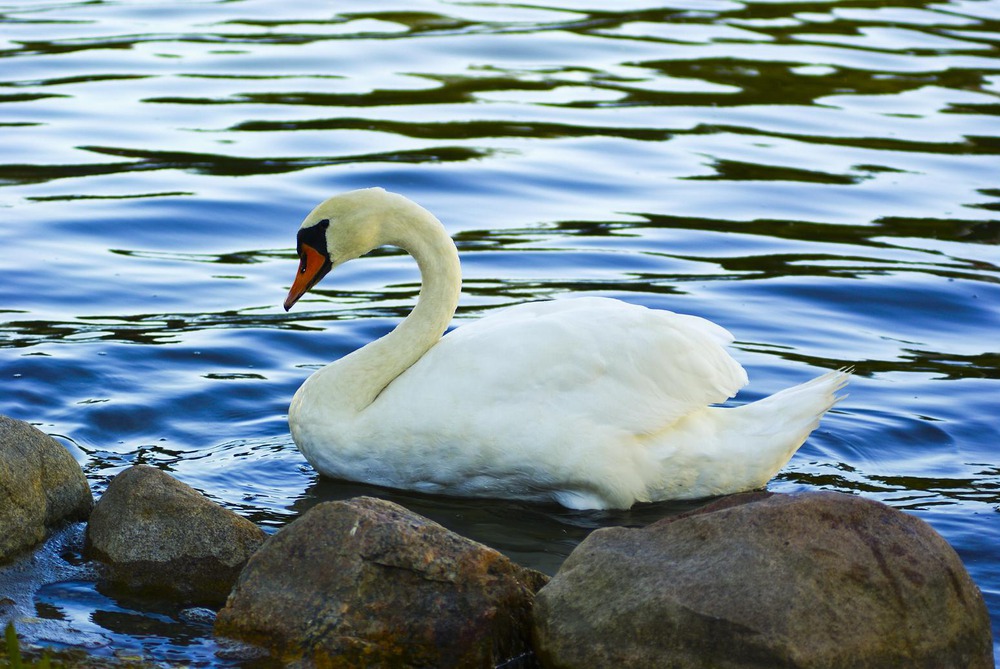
(0, 0), (1000, 665)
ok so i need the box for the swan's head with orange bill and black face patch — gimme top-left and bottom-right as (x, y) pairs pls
(285, 188), (404, 311)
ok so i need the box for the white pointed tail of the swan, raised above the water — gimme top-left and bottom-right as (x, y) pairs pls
(654, 369), (851, 497)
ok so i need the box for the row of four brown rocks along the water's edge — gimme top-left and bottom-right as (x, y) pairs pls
(0, 416), (994, 669)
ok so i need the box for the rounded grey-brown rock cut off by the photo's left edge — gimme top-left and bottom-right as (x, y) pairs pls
(0, 416), (94, 562)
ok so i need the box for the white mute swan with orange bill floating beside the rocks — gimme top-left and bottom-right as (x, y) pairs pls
(284, 188), (848, 509)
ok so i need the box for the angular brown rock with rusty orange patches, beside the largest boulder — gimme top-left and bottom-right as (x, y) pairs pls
(216, 497), (547, 667)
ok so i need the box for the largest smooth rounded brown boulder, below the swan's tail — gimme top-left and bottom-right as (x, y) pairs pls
(534, 492), (993, 669)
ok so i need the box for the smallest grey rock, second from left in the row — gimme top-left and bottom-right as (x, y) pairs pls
(87, 465), (267, 604)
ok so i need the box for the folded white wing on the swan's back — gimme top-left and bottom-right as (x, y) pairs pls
(386, 298), (747, 434)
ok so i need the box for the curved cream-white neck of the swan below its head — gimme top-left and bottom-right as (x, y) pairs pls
(303, 203), (462, 413)
